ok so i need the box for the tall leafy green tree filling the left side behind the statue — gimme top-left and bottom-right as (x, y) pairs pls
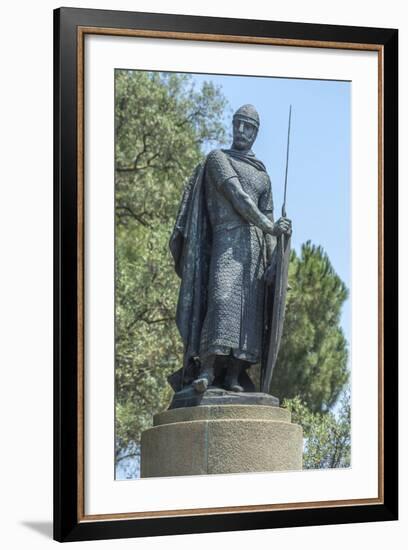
(115, 70), (230, 459)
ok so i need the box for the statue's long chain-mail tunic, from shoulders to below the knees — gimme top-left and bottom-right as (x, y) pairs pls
(199, 150), (275, 363)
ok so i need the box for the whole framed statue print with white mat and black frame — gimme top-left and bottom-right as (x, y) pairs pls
(54, 8), (398, 542)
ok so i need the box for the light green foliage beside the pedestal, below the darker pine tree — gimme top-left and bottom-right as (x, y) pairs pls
(283, 391), (351, 469)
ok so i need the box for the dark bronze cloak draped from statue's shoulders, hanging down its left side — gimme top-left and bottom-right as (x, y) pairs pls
(169, 150), (272, 390)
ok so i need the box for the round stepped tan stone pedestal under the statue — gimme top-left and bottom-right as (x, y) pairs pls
(141, 405), (303, 477)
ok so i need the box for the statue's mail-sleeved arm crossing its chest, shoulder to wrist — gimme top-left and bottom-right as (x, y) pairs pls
(207, 151), (275, 235)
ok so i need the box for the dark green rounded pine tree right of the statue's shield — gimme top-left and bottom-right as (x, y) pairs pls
(271, 242), (348, 412)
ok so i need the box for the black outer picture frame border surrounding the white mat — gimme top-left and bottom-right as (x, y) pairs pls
(54, 8), (398, 542)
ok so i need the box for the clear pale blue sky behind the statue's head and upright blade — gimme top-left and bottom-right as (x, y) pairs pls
(188, 75), (351, 342)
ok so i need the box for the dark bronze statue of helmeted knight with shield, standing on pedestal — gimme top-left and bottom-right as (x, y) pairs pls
(169, 105), (292, 403)
